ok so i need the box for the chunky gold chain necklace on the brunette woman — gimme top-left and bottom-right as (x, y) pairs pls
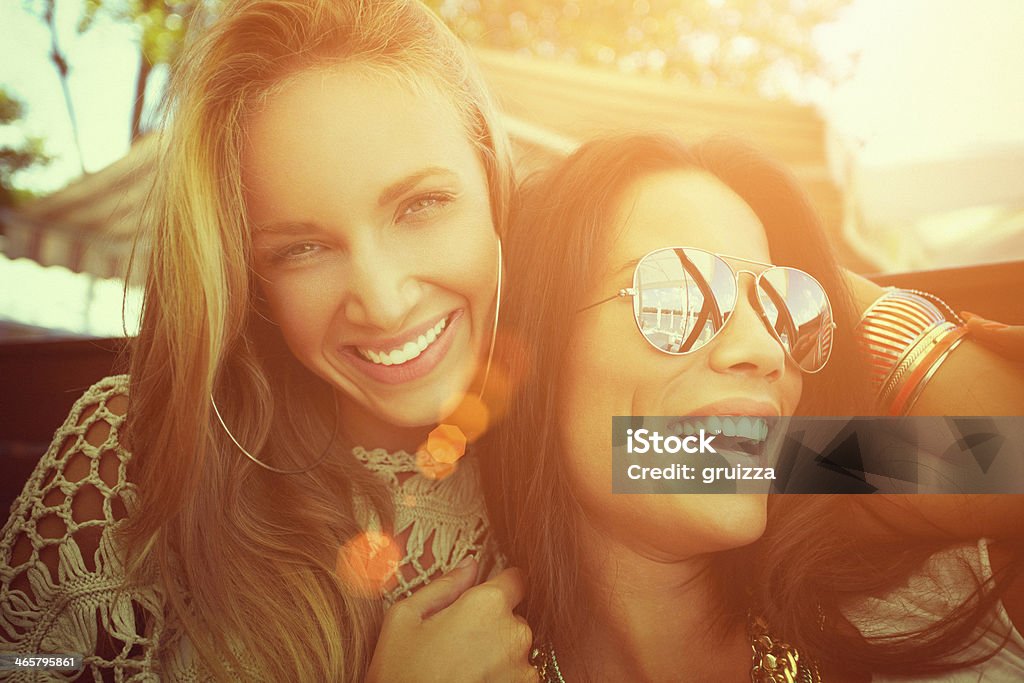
(529, 614), (822, 683)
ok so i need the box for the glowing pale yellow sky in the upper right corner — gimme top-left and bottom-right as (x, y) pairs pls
(818, 0), (1024, 166)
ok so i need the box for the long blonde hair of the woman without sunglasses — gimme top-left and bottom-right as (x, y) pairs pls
(122, 0), (514, 681)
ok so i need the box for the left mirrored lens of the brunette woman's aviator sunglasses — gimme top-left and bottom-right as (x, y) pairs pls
(633, 249), (736, 353)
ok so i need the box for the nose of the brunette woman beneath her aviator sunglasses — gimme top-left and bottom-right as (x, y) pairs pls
(709, 273), (786, 381)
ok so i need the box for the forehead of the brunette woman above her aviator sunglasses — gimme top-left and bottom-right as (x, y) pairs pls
(610, 169), (771, 266)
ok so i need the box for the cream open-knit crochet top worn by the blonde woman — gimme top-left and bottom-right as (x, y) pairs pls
(0, 375), (497, 681)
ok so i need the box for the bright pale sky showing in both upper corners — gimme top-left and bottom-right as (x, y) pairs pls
(0, 0), (1024, 190)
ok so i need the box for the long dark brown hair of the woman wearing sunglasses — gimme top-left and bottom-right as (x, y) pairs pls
(481, 134), (1024, 673)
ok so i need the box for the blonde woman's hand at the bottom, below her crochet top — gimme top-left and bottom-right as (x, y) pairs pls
(367, 558), (538, 683)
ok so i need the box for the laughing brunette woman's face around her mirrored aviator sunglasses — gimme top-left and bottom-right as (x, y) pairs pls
(559, 170), (802, 561)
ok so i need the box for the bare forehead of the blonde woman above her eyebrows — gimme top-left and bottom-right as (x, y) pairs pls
(242, 63), (483, 213)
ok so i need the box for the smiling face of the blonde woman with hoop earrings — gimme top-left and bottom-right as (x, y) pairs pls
(243, 65), (498, 432)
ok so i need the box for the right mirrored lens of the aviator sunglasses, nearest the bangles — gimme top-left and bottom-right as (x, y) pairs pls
(758, 266), (833, 373)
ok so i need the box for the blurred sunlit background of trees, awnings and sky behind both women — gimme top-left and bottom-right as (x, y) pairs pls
(0, 0), (1024, 343)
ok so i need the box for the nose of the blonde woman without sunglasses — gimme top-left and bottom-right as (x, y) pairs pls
(342, 244), (420, 332)
